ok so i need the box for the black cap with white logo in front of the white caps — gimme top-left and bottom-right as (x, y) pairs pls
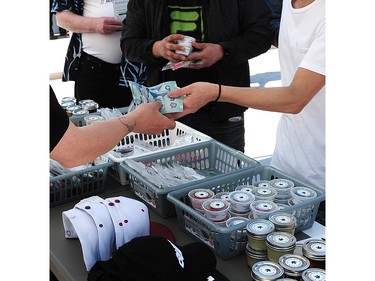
(88, 236), (229, 281)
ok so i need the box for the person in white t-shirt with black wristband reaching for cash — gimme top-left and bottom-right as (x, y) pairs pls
(169, 0), (325, 224)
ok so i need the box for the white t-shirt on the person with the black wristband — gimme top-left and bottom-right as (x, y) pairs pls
(271, 0), (325, 188)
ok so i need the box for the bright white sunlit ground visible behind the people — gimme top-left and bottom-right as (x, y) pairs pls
(49, 38), (281, 160)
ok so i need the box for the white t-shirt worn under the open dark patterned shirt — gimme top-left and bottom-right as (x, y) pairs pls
(82, 0), (126, 64)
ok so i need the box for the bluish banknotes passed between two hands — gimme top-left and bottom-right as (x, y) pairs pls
(129, 81), (183, 114)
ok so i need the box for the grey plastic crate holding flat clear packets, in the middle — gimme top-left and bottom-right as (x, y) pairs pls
(120, 140), (260, 218)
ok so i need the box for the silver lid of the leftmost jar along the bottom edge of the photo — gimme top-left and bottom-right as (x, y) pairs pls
(251, 261), (284, 281)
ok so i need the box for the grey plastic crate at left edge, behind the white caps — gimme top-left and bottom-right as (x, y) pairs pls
(50, 159), (113, 207)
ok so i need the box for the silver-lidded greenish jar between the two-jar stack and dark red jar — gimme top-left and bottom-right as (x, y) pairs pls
(266, 231), (297, 262)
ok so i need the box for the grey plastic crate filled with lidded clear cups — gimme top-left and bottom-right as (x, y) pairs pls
(167, 166), (325, 259)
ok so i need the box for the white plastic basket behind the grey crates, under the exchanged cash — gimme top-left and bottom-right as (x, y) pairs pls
(108, 121), (212, 185)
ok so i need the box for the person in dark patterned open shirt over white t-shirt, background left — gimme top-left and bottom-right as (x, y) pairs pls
(51, 0), (146, 108)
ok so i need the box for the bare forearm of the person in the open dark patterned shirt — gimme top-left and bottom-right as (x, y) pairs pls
(56, 11), (97, 33)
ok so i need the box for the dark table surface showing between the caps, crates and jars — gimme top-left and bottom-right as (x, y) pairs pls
(50, 176), (325, 281)
